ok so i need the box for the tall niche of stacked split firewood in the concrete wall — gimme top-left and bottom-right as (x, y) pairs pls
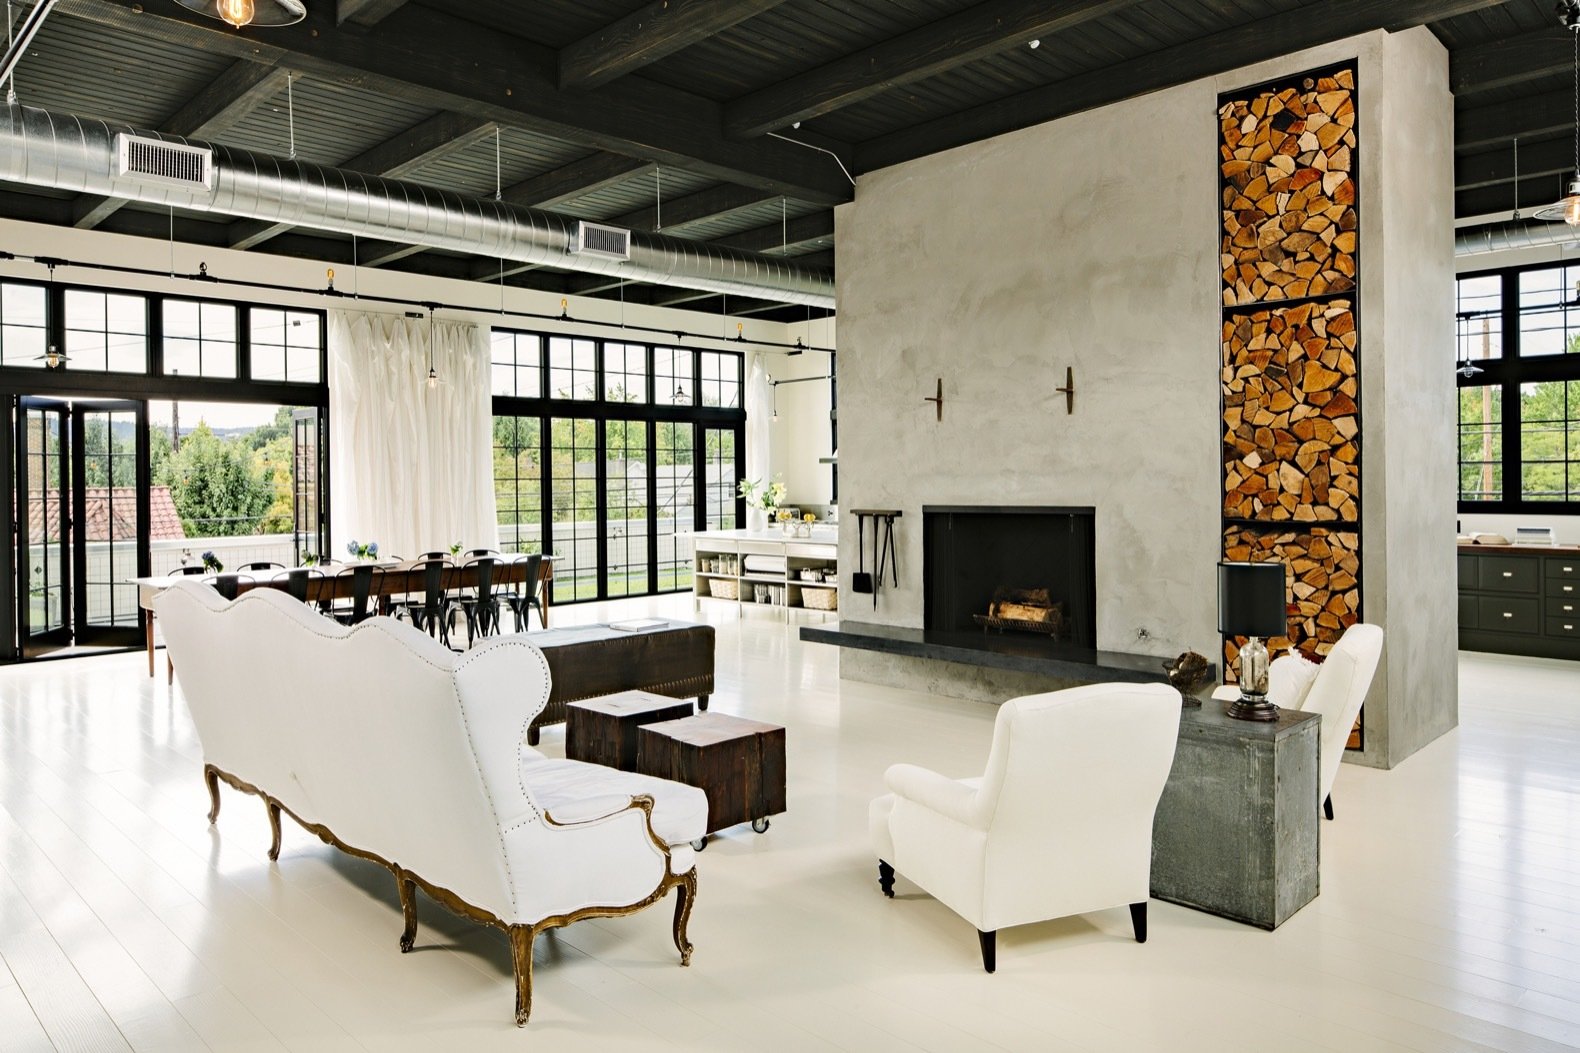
(1218, 68), (1360, 745)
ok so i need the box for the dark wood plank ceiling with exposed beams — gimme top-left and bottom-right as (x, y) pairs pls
(0, 0), (1575, 319)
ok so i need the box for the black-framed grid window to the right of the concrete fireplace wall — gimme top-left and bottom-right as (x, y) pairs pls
(1454, 262), (1580, 515)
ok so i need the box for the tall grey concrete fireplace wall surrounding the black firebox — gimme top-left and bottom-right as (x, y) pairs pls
(837, 30), (1455, 767)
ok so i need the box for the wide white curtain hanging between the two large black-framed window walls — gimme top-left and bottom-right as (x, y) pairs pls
(329, 311), (499, 558)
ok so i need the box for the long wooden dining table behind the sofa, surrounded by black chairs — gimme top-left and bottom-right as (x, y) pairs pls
(126, 553), (558, 677)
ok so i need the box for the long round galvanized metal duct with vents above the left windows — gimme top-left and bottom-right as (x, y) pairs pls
(0, 106), (834, 308)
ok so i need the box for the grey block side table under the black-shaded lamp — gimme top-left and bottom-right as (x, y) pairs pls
(1152, 699), (1322, 930)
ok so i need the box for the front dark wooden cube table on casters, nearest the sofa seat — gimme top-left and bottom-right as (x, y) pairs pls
(637, 713), (785, 849)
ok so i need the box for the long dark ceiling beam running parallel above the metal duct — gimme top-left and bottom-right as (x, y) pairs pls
(55, 0), (853, 204)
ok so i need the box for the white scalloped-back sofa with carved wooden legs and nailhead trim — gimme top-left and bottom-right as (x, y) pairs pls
(155, 582), (708, 1025)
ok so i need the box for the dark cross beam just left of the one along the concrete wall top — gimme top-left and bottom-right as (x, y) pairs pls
(724, 0), (1136, 138)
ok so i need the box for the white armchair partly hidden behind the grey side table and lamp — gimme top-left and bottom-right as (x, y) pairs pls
(1212, 621), (1383, 819)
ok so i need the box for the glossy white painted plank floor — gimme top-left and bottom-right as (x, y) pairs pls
(0, 596), (1580, 1053)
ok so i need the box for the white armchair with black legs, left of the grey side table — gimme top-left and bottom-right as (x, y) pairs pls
(869, 683), (1180, 972)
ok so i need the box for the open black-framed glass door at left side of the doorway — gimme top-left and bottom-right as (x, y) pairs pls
(14, 398), (149, 658)
